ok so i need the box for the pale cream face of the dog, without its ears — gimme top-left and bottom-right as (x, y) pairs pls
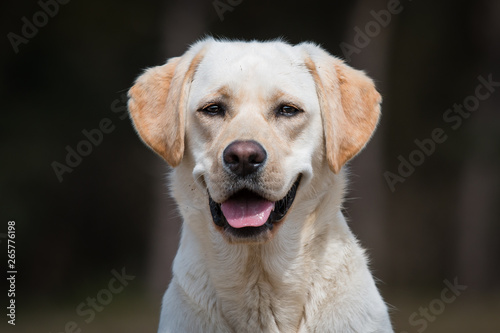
(186, 43), (323, 239)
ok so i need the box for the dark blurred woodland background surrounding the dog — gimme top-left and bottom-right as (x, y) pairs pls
(0, 0), (500, 333)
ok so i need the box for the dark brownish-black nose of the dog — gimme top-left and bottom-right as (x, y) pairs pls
(222, 141), (267, 177)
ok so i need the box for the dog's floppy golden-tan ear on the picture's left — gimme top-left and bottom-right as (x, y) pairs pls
(128, 51), (207, 167)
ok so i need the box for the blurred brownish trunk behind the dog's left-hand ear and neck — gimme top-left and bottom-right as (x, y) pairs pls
(149, 0), (211, 297)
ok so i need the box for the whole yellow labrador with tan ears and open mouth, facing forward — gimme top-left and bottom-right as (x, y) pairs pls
(129, 38), (393, 333)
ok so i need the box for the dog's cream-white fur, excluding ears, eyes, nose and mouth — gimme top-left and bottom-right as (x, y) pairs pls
(131, 39), (393, 333)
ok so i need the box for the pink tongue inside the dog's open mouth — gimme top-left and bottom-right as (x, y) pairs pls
(220, 198), (274, 228)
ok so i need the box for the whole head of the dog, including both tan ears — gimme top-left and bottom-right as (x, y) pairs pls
(129, 39), (381, 242)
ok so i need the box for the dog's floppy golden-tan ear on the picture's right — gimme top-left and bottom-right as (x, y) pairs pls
(301, 43), (382, 173)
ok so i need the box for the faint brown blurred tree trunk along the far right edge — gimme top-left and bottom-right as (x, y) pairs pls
(456, 1), (500, 290)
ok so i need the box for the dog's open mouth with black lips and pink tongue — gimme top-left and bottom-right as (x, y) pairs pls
(208, 175), (301, 238)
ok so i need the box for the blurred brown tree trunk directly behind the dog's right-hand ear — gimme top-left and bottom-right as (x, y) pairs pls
(345, 0), (397, 280)
